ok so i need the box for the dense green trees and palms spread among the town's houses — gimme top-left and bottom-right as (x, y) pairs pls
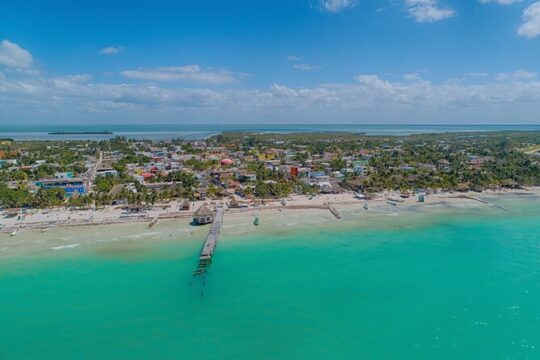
(0, 132), (540, 208)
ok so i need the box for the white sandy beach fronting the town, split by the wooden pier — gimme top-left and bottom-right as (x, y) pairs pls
(0, 188), (540, 258)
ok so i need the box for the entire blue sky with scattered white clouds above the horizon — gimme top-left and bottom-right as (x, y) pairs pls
(0, 0), (540, 124)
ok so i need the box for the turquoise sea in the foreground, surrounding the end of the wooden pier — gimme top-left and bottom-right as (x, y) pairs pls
(0, 199), (540, 359)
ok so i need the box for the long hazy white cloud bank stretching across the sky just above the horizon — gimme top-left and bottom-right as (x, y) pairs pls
(0, 69), (540, 121)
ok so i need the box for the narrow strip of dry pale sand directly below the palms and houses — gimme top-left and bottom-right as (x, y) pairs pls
(0, 187), (540, 234)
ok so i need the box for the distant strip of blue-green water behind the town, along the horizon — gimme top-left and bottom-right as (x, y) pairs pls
(0, 124), (540, 140)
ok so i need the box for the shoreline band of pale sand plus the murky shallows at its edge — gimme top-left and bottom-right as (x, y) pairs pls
(0, 189), (540, 260)
